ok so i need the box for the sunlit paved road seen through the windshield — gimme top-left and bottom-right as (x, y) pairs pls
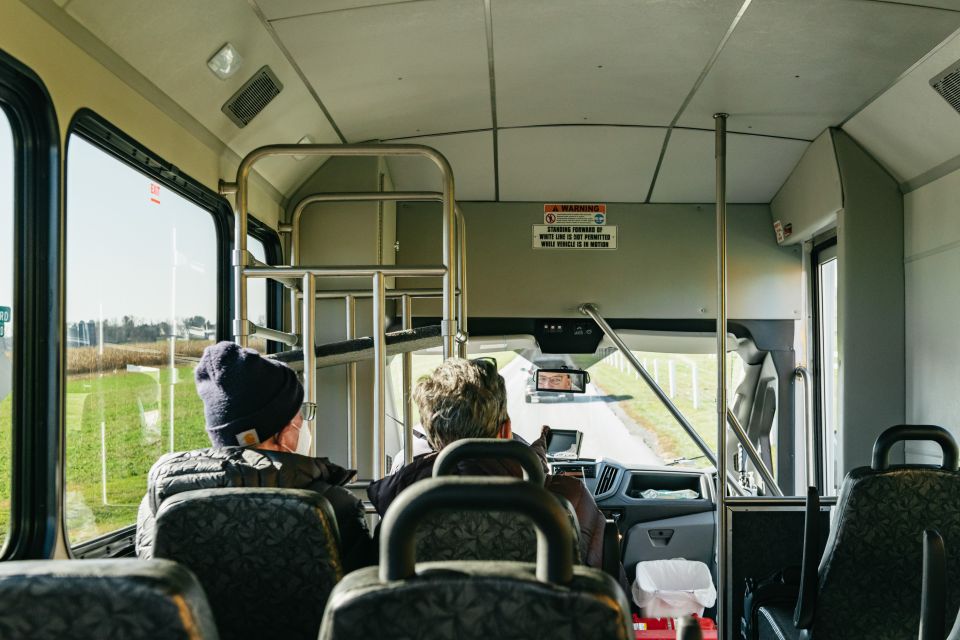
(500, 356), (663, 464)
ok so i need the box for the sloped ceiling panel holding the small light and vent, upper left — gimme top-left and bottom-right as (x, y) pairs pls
(66, 0), (339, 192)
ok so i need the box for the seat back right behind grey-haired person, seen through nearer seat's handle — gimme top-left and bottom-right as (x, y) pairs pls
(416, 438), (582, 563)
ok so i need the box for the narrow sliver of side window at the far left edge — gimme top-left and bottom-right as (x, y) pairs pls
(0, 109), (14, 549)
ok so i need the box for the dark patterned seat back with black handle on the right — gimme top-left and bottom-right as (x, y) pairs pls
(798, 425), (960, 640)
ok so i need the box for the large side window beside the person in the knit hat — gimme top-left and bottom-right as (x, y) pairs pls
(65, 134), (217, 545)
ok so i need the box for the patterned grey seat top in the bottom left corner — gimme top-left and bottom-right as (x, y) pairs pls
(0, 560), (217, 640)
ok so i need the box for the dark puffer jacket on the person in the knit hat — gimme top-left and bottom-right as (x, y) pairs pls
(136, 447), (374, 571)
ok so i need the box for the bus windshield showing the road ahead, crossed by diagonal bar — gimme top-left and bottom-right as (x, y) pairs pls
(390, 350), (744, 467)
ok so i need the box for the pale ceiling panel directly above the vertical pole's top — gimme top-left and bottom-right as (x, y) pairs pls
(680, 0), (960, 139)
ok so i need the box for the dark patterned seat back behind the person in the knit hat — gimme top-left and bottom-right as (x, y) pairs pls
(154, 489), (343, 640)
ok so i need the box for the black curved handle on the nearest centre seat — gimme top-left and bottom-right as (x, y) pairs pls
(380, 476), (573, 585)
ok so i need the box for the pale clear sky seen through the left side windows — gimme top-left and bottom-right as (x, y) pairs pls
(0, 124), (266, 336)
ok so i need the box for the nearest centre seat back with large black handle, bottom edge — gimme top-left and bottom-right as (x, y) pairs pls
(320, 477), (633, 640)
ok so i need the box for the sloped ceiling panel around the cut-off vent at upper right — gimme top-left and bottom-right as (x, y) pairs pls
(843, 31), (960, 182)
